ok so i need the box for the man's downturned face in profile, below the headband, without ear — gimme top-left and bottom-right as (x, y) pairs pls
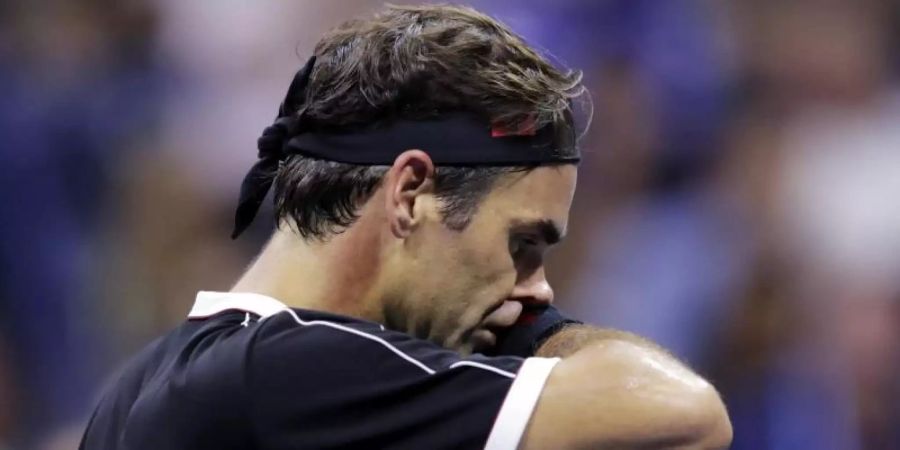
(385, 165), (577, 353)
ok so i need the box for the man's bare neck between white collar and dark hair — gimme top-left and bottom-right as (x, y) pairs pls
(231, 224), (384, 323)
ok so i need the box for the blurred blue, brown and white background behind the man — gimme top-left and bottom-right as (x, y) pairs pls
(0, 0), (900, 450)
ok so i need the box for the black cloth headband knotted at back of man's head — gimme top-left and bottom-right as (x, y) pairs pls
(231, 56), (580, 239)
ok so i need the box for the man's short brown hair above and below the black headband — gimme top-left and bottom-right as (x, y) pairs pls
(275, 5), (584, 238)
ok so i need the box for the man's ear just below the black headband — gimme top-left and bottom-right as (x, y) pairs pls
(384, 150), (434, 239)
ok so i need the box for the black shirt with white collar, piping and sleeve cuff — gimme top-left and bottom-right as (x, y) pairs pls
(80, 292), (558, 450)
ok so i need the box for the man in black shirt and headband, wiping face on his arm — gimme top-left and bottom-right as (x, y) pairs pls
(82, 6), (731, 449)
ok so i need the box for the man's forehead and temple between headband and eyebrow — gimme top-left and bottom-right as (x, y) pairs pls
(479, 164), (577, 231)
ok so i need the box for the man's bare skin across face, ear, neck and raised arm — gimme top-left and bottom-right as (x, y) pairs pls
(233, 150), (732, 449)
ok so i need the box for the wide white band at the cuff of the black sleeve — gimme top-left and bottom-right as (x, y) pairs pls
(484, 358), (559, 450)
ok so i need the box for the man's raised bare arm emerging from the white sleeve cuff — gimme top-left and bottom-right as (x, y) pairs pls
(520, 325), (732, 450)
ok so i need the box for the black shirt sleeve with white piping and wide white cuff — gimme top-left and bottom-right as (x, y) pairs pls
(246, 310), (558, 450)
